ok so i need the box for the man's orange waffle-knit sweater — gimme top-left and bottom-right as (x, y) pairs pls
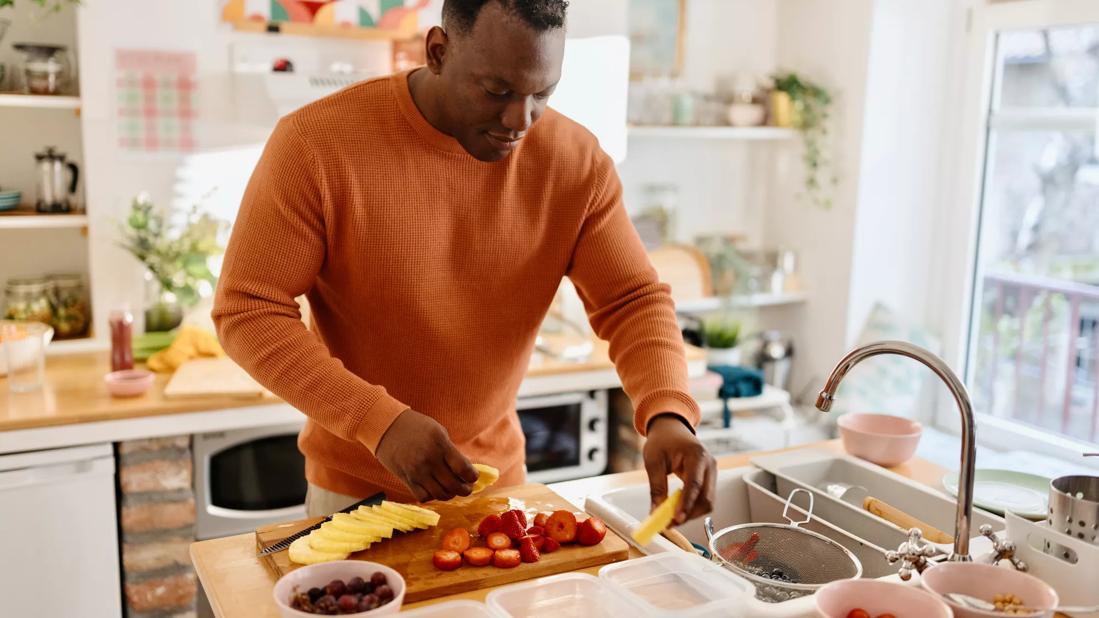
(213, 73), (698, 499)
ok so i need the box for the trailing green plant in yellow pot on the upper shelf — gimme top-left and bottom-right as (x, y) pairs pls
(773, 71), (836, 208)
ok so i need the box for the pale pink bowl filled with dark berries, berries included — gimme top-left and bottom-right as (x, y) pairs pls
(275, 560), (404, 618)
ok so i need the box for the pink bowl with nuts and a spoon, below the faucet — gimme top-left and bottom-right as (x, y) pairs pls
(920, 562), (1059, 618)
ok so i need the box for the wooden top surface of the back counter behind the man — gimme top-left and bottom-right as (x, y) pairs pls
(0, 341), (706, 431)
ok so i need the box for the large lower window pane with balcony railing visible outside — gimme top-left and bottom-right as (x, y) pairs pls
(969, 122), (1099, 441)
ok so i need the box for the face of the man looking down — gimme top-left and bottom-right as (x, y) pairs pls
(430, 2), (565, 162)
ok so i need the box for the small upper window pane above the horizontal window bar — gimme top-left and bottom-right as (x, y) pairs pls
(996, 24), (1099, 108)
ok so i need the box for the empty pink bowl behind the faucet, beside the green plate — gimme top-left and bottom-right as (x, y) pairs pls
(836, 415), (923, 467)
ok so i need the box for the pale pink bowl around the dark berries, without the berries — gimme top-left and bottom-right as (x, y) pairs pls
(274, 560), (406, 618)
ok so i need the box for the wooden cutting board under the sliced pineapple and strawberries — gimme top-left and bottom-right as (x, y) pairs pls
(256, 484), (630, 603)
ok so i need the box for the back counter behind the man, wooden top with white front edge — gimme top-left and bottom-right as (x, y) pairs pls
(0, 341), (706, 453)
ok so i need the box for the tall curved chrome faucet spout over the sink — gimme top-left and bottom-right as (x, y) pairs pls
(817, 341), (977, 562)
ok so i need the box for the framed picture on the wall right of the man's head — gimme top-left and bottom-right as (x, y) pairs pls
(629, 0), (687, 79)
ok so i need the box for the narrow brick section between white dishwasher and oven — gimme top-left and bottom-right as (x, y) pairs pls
(119, 435), (198, 618)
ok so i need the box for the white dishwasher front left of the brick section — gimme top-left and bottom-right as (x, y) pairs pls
(0, 444), (122, 618)
